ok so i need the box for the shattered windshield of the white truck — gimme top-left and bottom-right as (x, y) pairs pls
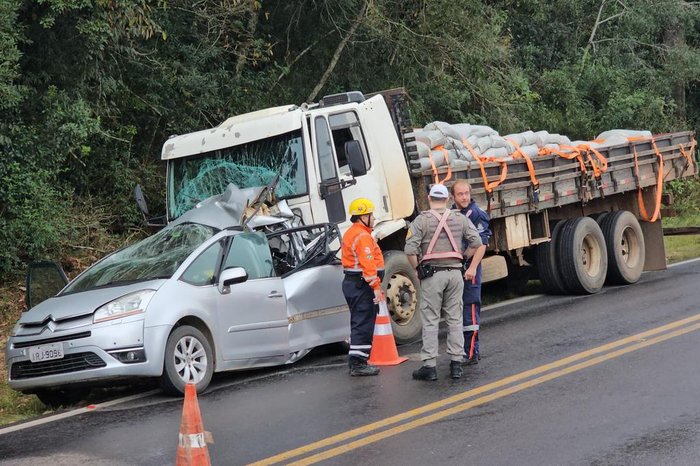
(168, 130), (308, 220)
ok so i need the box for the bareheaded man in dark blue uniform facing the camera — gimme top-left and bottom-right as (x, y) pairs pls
(451, 180), (491, 365)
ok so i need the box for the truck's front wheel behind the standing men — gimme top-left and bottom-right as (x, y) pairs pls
(382, 251), (423, 344)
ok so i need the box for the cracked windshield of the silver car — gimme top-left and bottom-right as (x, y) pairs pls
(64, 223), (216, 293)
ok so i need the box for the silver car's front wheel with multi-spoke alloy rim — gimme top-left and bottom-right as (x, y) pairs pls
(160, 325), (214, 396)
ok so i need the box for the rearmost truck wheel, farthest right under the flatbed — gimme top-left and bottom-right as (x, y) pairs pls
(600, 210), (645, 285)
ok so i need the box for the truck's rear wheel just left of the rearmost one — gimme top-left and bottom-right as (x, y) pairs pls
(555, 217), (608, 294)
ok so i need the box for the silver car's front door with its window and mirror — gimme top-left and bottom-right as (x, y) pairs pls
(217, 232), (289, 361)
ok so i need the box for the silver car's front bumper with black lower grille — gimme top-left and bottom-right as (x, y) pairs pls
(5, 320), (170, 392)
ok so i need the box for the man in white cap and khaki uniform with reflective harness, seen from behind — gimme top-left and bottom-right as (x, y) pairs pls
(404, 184), (481, 380)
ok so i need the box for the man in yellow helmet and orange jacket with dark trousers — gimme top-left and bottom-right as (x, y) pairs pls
(341, 198), (384, 376)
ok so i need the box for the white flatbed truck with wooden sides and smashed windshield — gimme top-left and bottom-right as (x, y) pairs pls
(153, 90), (698, 343)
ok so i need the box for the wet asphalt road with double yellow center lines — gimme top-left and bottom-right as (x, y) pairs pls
(0, 261), (700, 466)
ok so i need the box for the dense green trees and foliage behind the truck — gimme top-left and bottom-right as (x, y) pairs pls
(0, 0), (700, 277)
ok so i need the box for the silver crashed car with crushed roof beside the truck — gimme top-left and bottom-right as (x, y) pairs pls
(5, 186), (350, 405)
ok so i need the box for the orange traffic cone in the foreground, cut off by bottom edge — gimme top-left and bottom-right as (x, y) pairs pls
(175, 383), (211, 466)
